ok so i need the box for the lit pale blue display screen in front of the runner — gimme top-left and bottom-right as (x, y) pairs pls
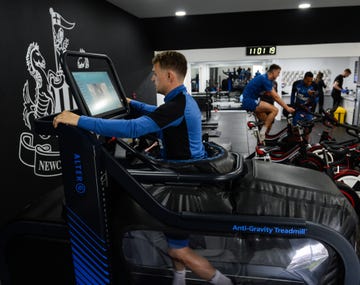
(72, 71), (125, 117)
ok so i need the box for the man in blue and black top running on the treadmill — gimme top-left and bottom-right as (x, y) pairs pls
(53, 51), (232, 285)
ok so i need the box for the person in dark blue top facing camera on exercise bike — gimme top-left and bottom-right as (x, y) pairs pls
(290, 71), (318, 141)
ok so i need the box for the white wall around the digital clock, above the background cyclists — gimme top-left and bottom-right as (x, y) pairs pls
(180, 43), (360, 119)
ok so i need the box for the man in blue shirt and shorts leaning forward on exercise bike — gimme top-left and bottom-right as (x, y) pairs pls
(242, 64), (295, 142)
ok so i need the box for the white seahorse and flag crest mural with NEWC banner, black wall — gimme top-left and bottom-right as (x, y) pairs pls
(19, 8), (89, 177)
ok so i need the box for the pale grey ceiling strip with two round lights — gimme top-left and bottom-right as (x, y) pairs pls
(106, 0), (360, 18)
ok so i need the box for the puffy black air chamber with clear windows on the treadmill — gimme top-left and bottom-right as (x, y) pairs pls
(121, 160), (359, 285)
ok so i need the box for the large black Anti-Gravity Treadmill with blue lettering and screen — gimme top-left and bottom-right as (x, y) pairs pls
(28, 51), (360, 285)
